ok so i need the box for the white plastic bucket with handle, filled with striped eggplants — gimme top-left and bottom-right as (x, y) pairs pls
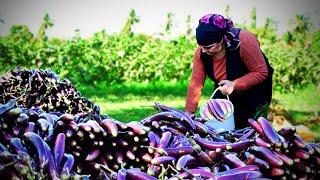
(200, 87), (235, 131)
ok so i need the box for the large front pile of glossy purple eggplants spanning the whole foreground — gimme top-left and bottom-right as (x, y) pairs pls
(0, 68), (320, 180)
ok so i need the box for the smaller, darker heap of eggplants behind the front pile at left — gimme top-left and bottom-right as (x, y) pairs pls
(0, 68), (100, 114)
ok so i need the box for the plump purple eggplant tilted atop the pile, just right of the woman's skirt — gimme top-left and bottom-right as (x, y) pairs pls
(257, 117), (281, 147)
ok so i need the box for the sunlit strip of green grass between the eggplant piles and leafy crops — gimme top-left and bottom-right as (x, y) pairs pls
(78, 81), (320, 132)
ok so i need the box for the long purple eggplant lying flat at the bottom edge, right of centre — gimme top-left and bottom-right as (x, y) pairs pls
(213, 170), (263, 180)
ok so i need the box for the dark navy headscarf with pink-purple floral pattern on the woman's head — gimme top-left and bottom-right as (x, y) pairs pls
(196, 14), (239, 47)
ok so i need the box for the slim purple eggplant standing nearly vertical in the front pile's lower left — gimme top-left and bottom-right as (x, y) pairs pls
(53, 133), (66, 167)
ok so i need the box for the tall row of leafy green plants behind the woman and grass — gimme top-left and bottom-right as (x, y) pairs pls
(0, 8), (320, 91)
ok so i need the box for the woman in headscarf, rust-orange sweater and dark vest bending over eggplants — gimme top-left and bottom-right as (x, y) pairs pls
(185, 14), (273, 129)
